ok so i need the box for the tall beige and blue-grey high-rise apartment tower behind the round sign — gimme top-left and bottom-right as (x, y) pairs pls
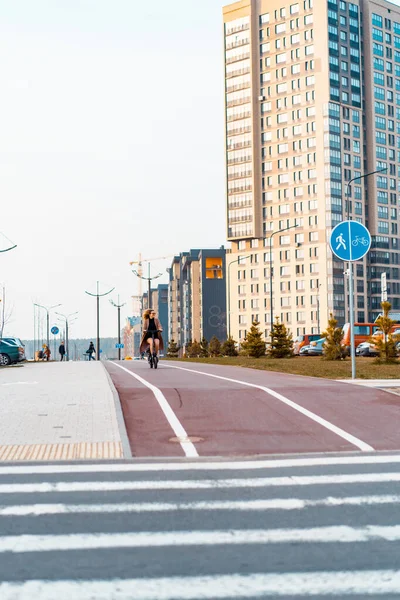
(223, 0), (400, 342)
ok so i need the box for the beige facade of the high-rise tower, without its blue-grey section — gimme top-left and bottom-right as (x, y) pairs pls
(224, 0), (332, 342)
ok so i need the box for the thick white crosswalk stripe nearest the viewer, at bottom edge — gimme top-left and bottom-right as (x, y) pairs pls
(0, 570), (400, 600)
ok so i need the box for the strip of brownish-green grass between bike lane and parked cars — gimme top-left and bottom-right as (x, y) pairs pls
(167, 356), (400, 379)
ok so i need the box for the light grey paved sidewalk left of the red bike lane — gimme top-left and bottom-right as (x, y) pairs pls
(0, 361), (130, 461)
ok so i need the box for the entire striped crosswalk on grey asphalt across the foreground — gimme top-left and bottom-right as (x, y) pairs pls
(0, 453), (400, 600)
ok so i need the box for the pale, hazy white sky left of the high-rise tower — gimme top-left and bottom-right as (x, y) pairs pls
(0, 0), (226, 339)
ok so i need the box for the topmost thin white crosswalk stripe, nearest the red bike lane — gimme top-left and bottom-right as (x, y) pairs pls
(0, 454), (400, 477)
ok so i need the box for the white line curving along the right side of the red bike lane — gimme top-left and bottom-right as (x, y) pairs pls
(164, 365), (374, 452)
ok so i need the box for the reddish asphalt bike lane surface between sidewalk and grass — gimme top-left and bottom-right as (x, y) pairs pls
(104, 361), (400, 457)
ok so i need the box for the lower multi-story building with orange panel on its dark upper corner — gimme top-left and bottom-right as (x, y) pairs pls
(169, 246), (226, 351)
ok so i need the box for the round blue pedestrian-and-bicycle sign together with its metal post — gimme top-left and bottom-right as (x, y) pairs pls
(330, 221), (371, 379)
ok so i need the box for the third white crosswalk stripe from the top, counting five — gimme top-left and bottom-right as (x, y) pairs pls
(0, 495), (400, 517)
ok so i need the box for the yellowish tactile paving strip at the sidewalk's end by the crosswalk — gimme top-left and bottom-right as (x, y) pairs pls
(0, 442), (124, 462)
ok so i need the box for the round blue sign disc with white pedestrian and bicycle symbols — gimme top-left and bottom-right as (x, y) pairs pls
(330, 221), (371, 262)
